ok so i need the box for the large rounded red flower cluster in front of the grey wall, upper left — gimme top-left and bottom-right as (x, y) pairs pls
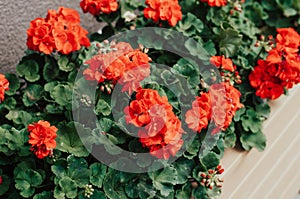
(27, 7), (90, 54)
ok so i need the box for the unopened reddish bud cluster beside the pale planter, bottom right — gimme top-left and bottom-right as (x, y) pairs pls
(200, 165), (224, 189)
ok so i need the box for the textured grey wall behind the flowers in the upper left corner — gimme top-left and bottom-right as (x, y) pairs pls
(0, 0), (100, 73)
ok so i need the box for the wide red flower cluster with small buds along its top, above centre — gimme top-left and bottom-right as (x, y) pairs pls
(83, 42), (151, 94)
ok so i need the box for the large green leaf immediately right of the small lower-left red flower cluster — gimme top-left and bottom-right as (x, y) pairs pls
(56, 122), (92, 157)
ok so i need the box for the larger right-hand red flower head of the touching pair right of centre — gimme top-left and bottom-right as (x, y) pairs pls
(209, 82), (243, 130)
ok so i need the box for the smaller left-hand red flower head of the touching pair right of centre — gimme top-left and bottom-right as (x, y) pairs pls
(185, 93), (211, 133)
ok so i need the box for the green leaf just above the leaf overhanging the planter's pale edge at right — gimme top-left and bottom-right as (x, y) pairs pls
(241, 108), (262, 133)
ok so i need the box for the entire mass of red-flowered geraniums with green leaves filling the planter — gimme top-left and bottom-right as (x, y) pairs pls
(0, 0), (300, 199)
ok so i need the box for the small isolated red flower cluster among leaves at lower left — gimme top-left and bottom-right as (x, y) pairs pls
(27, 120), (58, 159)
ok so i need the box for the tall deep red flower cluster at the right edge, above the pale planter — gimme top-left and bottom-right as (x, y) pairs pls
(249, 28), (300, 100)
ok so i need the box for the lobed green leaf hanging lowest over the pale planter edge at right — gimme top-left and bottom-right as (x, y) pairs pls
(240, 131), (267, 151)
